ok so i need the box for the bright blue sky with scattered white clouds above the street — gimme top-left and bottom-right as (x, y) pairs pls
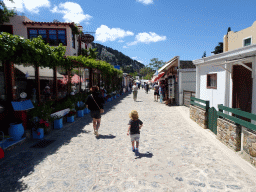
(4, 0), (256, 65)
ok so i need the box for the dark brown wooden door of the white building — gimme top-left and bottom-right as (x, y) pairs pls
(232, 63), (252, 113)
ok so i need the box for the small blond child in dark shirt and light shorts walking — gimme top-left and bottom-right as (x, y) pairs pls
(127, 110), (143, 155)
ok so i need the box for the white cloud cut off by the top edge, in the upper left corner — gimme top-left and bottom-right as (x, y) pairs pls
(4, 0), (50, 13)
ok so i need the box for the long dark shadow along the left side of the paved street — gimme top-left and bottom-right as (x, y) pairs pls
(0, 92), (131, 192)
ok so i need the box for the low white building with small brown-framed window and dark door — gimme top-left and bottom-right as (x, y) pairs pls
(193, 44), (256, 113)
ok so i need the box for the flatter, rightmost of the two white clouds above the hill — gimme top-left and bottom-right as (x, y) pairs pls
(127, 32), (166, 46)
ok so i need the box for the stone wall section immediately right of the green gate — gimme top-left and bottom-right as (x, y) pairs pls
(217, 118), (241, 151)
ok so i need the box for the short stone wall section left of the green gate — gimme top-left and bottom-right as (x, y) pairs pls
(189, 105), (207, 129)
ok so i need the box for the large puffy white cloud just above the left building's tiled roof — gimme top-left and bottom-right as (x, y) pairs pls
(51, 2), (92, 24)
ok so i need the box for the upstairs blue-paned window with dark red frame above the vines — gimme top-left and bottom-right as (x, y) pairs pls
(28, 29), (67, 46)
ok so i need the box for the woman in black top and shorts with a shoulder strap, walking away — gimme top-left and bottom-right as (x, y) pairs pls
(85, 86), (104, 137)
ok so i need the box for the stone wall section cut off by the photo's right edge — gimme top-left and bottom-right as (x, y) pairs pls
(242, 127), (256, 166)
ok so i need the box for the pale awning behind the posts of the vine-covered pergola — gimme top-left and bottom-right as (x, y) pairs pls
(14, 64), (63, 80)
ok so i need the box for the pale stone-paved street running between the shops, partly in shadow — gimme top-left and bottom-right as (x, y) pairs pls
(0, 90), (256, 192)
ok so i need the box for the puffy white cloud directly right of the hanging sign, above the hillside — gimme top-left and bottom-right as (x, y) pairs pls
(96, 25), (134, 42)
